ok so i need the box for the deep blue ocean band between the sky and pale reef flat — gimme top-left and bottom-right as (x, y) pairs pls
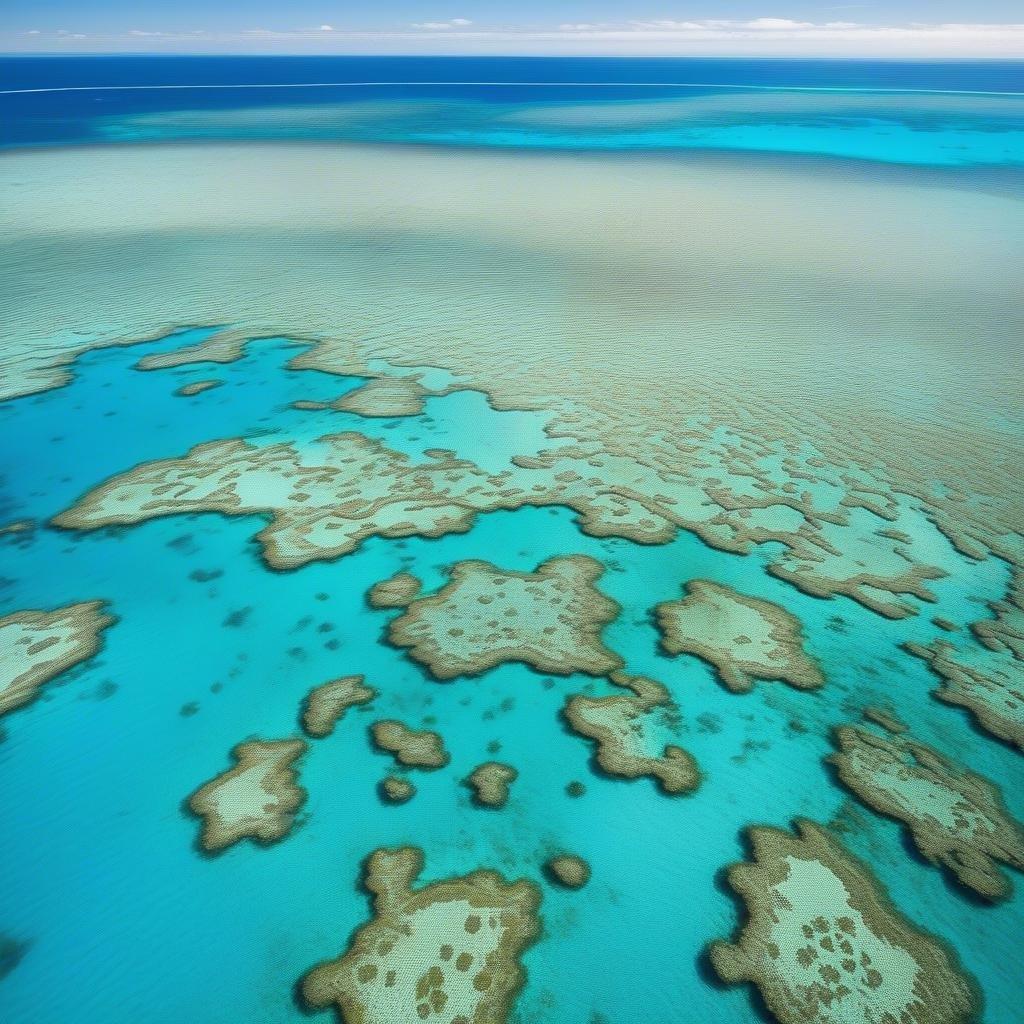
(0, 56), (1024, 166)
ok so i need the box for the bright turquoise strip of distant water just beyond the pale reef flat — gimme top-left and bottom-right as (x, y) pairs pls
(44, 96), (1024, 167)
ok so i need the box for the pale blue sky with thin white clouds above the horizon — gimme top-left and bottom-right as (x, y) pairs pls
(0, 0), (1024, 57)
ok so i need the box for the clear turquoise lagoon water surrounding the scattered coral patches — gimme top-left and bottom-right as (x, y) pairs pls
(0, 332), (1024, 1024)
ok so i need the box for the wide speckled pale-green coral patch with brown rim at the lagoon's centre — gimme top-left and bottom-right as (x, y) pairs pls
(388, 555), (623, 679)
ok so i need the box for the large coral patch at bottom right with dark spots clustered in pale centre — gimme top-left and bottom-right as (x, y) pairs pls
(710, 820), (980, 1024)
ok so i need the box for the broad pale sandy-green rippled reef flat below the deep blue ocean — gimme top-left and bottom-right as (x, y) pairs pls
(0, 146), (1024, 638)
